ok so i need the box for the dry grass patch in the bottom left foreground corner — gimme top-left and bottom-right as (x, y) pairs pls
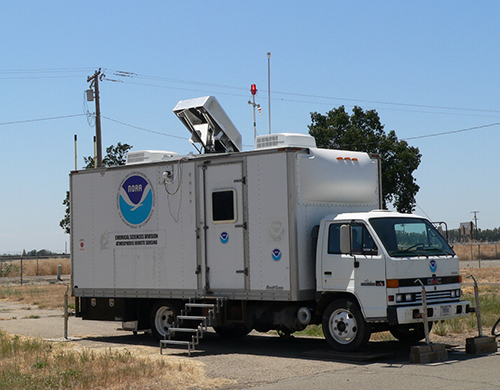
(0, 331), (230, 390)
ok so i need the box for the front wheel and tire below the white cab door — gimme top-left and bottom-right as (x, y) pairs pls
(322, 299), (371, 352)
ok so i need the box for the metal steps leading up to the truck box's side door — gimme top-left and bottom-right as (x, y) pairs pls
(160, 297), (225, 356)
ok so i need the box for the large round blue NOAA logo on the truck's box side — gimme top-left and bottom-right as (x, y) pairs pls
(118, 172), (154, 227)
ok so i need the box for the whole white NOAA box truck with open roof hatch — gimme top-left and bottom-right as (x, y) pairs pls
(70, 97), (470, 351)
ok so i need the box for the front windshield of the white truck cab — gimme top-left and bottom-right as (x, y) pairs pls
(370, 218), (455, 257)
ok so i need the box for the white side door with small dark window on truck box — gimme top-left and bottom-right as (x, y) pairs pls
(202, 162), (248, 290)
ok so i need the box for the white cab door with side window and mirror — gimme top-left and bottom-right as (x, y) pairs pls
(321, 222), (387, 319)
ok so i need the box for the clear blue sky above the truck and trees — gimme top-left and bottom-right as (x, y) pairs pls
(0, 0), (500, 253)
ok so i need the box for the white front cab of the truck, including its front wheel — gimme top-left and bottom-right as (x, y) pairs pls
(316, 210), (470, 351)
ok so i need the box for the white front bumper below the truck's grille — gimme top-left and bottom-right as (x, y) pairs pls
(387, 301), (471, 325)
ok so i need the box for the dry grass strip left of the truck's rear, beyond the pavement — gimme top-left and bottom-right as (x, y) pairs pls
(0, 284), (70, 309)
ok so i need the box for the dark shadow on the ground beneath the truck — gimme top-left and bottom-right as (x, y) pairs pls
(83, 332), (481, 365)
